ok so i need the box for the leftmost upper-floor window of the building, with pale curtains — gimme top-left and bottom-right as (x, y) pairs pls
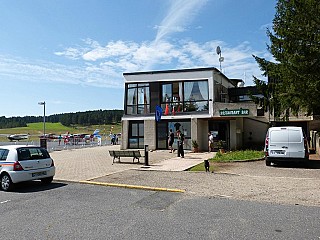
(126, 83), (150, 115)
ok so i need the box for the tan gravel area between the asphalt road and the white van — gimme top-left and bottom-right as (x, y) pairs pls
(93, 161), (320, 206)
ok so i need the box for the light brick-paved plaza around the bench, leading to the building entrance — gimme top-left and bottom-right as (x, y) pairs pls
(50, 145), (215, 181)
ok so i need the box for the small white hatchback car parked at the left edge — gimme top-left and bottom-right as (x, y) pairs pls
(0, 145), (55, 191)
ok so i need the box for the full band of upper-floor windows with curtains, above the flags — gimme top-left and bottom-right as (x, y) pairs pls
(125, 80), (209, 115)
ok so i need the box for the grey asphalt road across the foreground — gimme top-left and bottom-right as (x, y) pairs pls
(0, 182), (320, 240)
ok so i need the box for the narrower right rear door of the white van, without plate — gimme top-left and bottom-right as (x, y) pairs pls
(288, 127), (305, 158)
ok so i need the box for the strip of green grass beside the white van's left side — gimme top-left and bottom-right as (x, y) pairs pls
(189, 150), (264, 171)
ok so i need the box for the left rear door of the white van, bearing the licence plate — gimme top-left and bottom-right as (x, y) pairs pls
(268, 127), (289, 158)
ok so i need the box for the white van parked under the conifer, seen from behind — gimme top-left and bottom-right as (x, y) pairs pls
(264, 126), (309, 166)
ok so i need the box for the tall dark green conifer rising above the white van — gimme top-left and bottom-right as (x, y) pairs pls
(254, 0), (320, 114)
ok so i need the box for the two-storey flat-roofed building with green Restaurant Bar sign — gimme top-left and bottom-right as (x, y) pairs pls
(121, 67), (270, 151)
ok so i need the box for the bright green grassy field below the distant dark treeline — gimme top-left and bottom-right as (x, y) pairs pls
(0, 122), (121, 141)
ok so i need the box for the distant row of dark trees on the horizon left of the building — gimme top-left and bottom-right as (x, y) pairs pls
(0, 110), (123, 128)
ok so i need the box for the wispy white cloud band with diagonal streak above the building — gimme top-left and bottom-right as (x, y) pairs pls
(0, 0), (271, 88)
